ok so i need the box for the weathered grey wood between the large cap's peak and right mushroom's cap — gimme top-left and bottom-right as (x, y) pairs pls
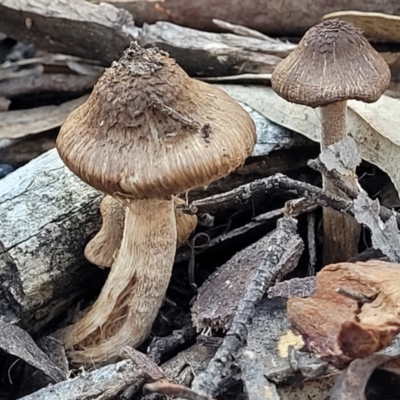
(139, 22), (296, 76)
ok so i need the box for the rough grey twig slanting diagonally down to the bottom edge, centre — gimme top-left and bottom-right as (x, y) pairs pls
(192, 217), (303, 396)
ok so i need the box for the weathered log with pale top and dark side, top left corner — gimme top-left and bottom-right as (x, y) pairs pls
(0, 0), (137, 64)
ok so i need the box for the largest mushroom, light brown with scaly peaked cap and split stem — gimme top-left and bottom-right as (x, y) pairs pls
(57, 43), (256, 365)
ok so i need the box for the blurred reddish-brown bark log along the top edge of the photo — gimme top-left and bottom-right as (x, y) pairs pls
(92, 0), (400, 36)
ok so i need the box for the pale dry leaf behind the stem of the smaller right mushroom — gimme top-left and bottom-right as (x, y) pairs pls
(217, 85), (400, 196)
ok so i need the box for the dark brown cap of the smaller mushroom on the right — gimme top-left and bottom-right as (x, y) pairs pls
(271, 19), (391, 107)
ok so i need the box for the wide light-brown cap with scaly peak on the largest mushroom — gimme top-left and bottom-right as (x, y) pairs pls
(57, 43), (256, 199)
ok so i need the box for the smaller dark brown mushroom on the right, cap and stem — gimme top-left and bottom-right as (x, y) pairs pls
(271, 19), (391, 264)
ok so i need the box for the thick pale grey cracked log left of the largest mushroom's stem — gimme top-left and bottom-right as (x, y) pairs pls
(0, 150), (101, 332)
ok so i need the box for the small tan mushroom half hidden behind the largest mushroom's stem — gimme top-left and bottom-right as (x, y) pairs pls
(85, 195), (197, 268)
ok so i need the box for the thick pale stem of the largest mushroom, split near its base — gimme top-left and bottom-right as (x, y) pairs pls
(65, 199), (177, 364)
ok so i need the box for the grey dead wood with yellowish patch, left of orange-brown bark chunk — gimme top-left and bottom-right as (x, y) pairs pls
(241, 298), (335, 400)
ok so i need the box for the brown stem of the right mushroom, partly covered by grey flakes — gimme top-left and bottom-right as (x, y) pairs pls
(321, 101), (361, 265)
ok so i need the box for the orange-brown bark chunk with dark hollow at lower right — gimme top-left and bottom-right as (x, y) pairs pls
(288, 260), (400, 367)
